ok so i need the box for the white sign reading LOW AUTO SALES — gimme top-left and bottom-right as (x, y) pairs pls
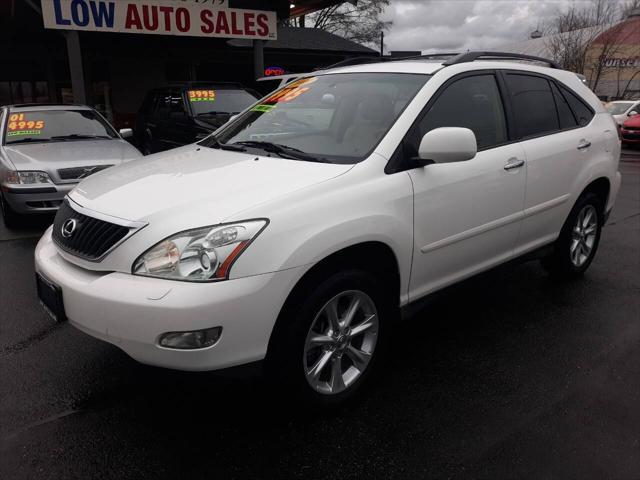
(42, 0), (277, 40)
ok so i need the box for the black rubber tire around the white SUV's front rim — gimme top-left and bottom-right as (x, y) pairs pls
(266, 269), (395, 408)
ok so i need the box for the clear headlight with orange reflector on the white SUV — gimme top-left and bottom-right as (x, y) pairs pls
(133, 219), (269, 282)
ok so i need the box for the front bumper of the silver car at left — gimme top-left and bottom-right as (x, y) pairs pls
(2, 183), (77, 214)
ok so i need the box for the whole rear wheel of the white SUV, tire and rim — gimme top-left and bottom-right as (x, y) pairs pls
(542, 189), (604, 277)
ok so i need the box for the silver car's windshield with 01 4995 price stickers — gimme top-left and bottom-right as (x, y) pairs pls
(4, 110), (118, 145)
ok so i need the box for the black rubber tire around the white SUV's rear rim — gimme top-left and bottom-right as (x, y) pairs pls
(540, 192), (604, 278)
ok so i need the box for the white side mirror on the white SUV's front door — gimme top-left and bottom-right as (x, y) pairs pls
(418, 127), (478, 166)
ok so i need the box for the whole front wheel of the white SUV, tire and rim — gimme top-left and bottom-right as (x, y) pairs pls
(267, 270), (393, 406)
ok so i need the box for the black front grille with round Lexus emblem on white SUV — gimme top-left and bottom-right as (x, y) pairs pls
(52, 201), (129, 261)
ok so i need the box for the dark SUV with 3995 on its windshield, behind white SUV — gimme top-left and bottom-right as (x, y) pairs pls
(135, 82), (260, 155)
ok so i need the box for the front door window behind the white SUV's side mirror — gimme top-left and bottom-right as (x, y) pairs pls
(410, 74), (507, 152)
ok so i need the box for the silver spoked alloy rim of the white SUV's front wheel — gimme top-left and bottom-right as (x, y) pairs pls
(303, 290), (379, 395)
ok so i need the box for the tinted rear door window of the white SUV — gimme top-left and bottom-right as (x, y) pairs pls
(506, 73), (560, 138)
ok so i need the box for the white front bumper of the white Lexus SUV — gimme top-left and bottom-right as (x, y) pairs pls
(35, 228), (303, 370)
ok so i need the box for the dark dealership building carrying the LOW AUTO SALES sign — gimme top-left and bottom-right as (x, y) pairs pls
(0, 0), (378, 127)
